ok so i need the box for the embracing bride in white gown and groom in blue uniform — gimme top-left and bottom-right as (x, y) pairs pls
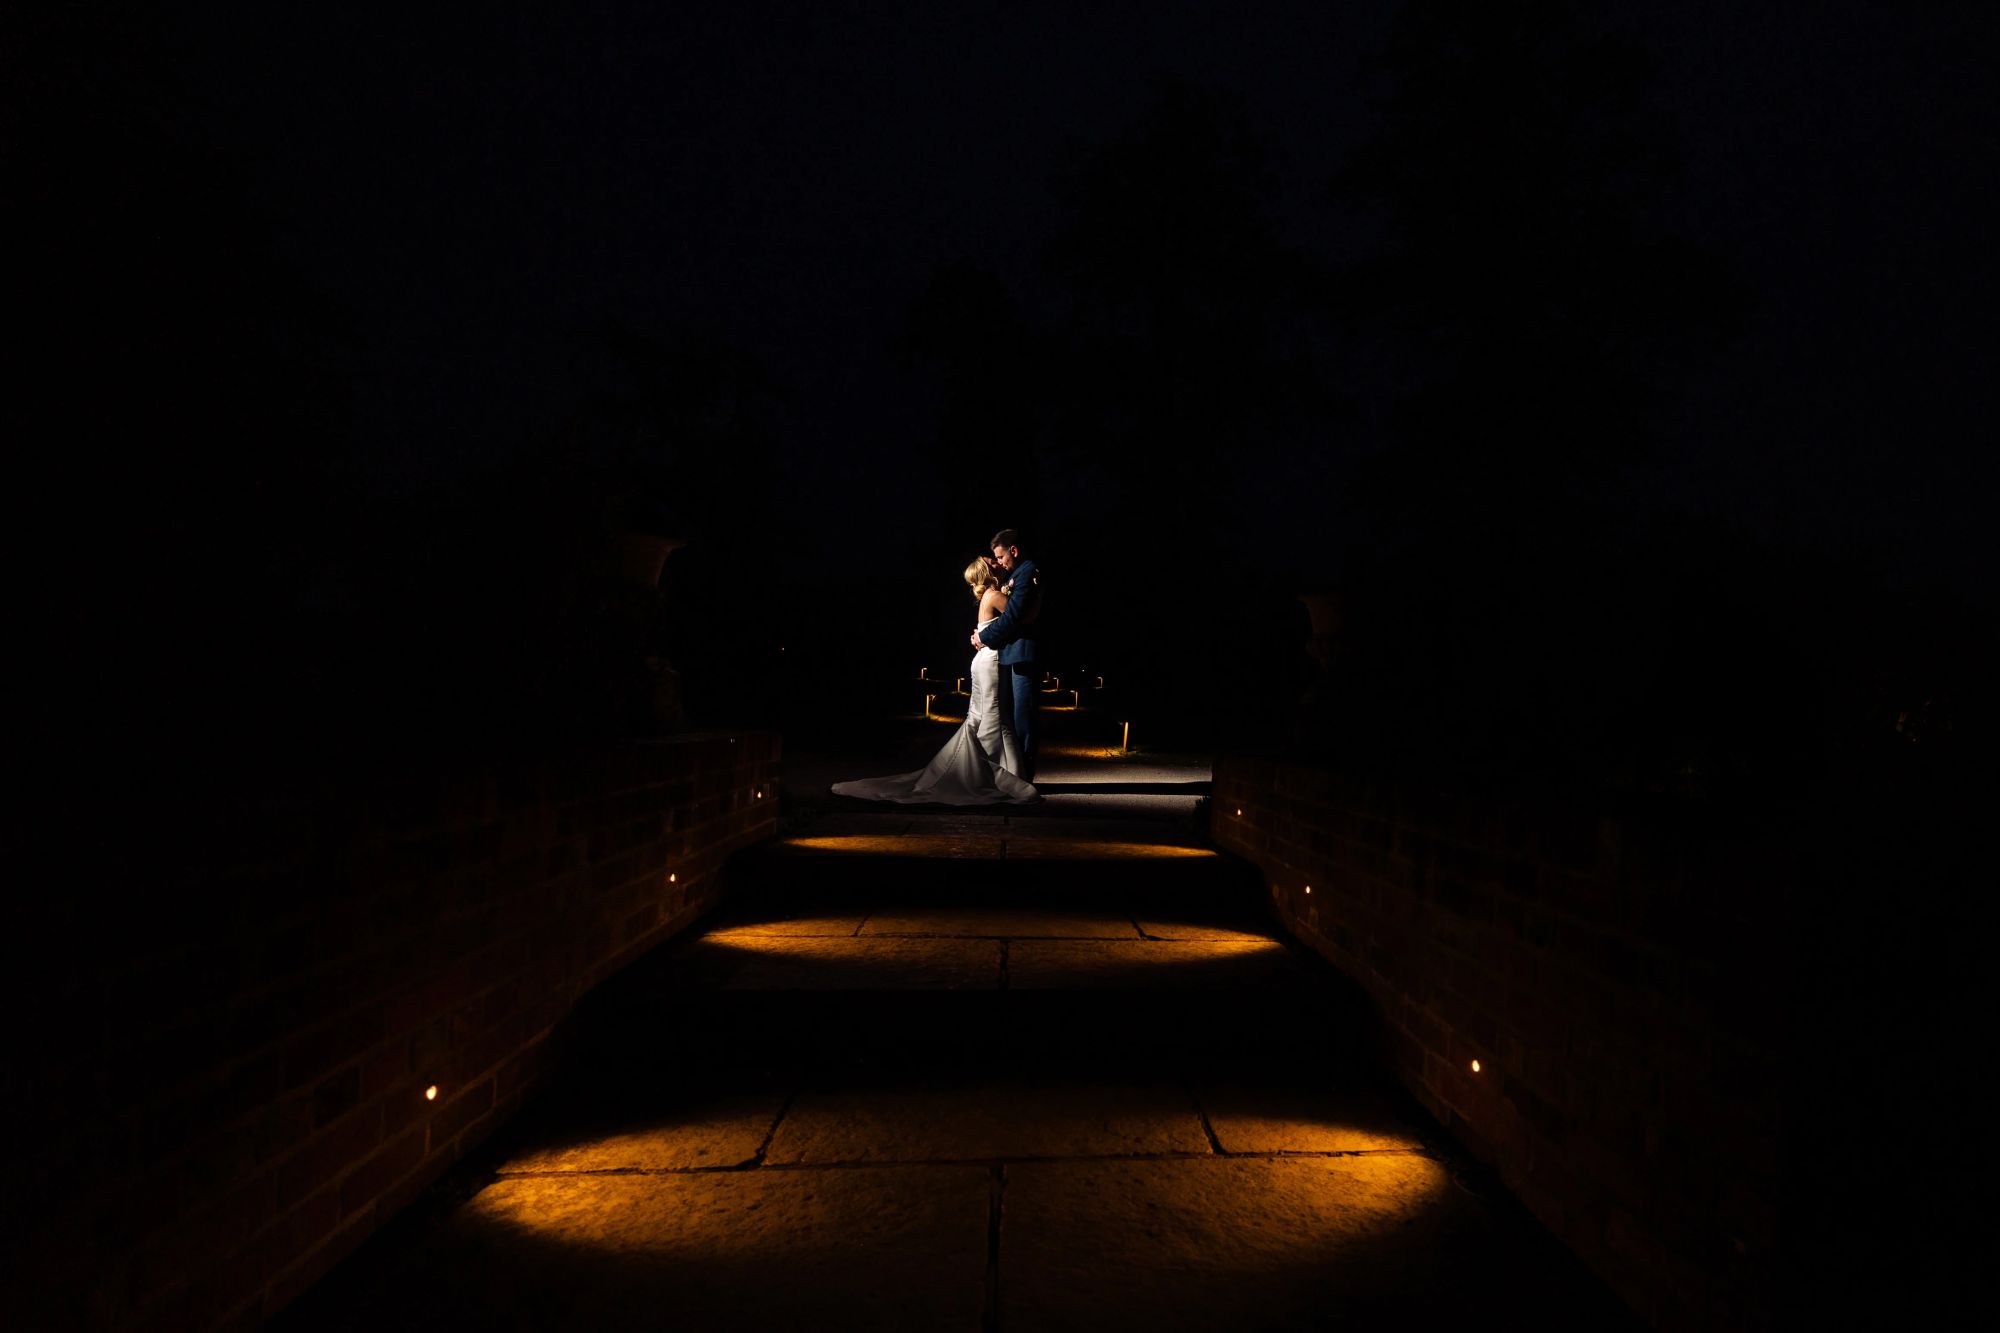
(832, 528), (1042, 805)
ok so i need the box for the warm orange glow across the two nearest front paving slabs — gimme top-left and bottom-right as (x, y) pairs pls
(474, 1144), (1474, 1280)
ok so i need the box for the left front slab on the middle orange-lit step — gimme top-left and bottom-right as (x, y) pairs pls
(674, 935), (1000, 991)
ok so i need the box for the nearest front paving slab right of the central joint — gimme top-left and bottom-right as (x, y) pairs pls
(1000, 1155), (1482, 1333)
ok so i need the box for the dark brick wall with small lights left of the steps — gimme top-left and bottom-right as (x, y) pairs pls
(15, 733), (778, 1329)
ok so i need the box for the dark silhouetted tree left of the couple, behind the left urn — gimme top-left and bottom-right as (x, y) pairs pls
(508, 324), (796, 729)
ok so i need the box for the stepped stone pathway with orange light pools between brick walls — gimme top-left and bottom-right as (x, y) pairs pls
(278, 752), (1624, 1331)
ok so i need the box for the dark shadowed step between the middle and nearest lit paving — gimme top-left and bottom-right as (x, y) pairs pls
(564, 941), (1380, 1083)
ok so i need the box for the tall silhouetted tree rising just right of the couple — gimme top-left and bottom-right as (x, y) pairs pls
(1044, 82), (1328, 736)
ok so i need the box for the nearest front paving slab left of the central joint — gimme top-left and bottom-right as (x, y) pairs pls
(430, 1167), (992, 1333)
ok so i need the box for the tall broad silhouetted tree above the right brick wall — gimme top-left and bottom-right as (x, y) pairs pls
(1304, 0), (1734, 773)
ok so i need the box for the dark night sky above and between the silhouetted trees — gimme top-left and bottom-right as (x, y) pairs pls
(121, 0), (2000, 592)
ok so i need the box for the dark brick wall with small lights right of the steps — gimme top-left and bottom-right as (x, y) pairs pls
(1212, 757), (1800, 1329)
